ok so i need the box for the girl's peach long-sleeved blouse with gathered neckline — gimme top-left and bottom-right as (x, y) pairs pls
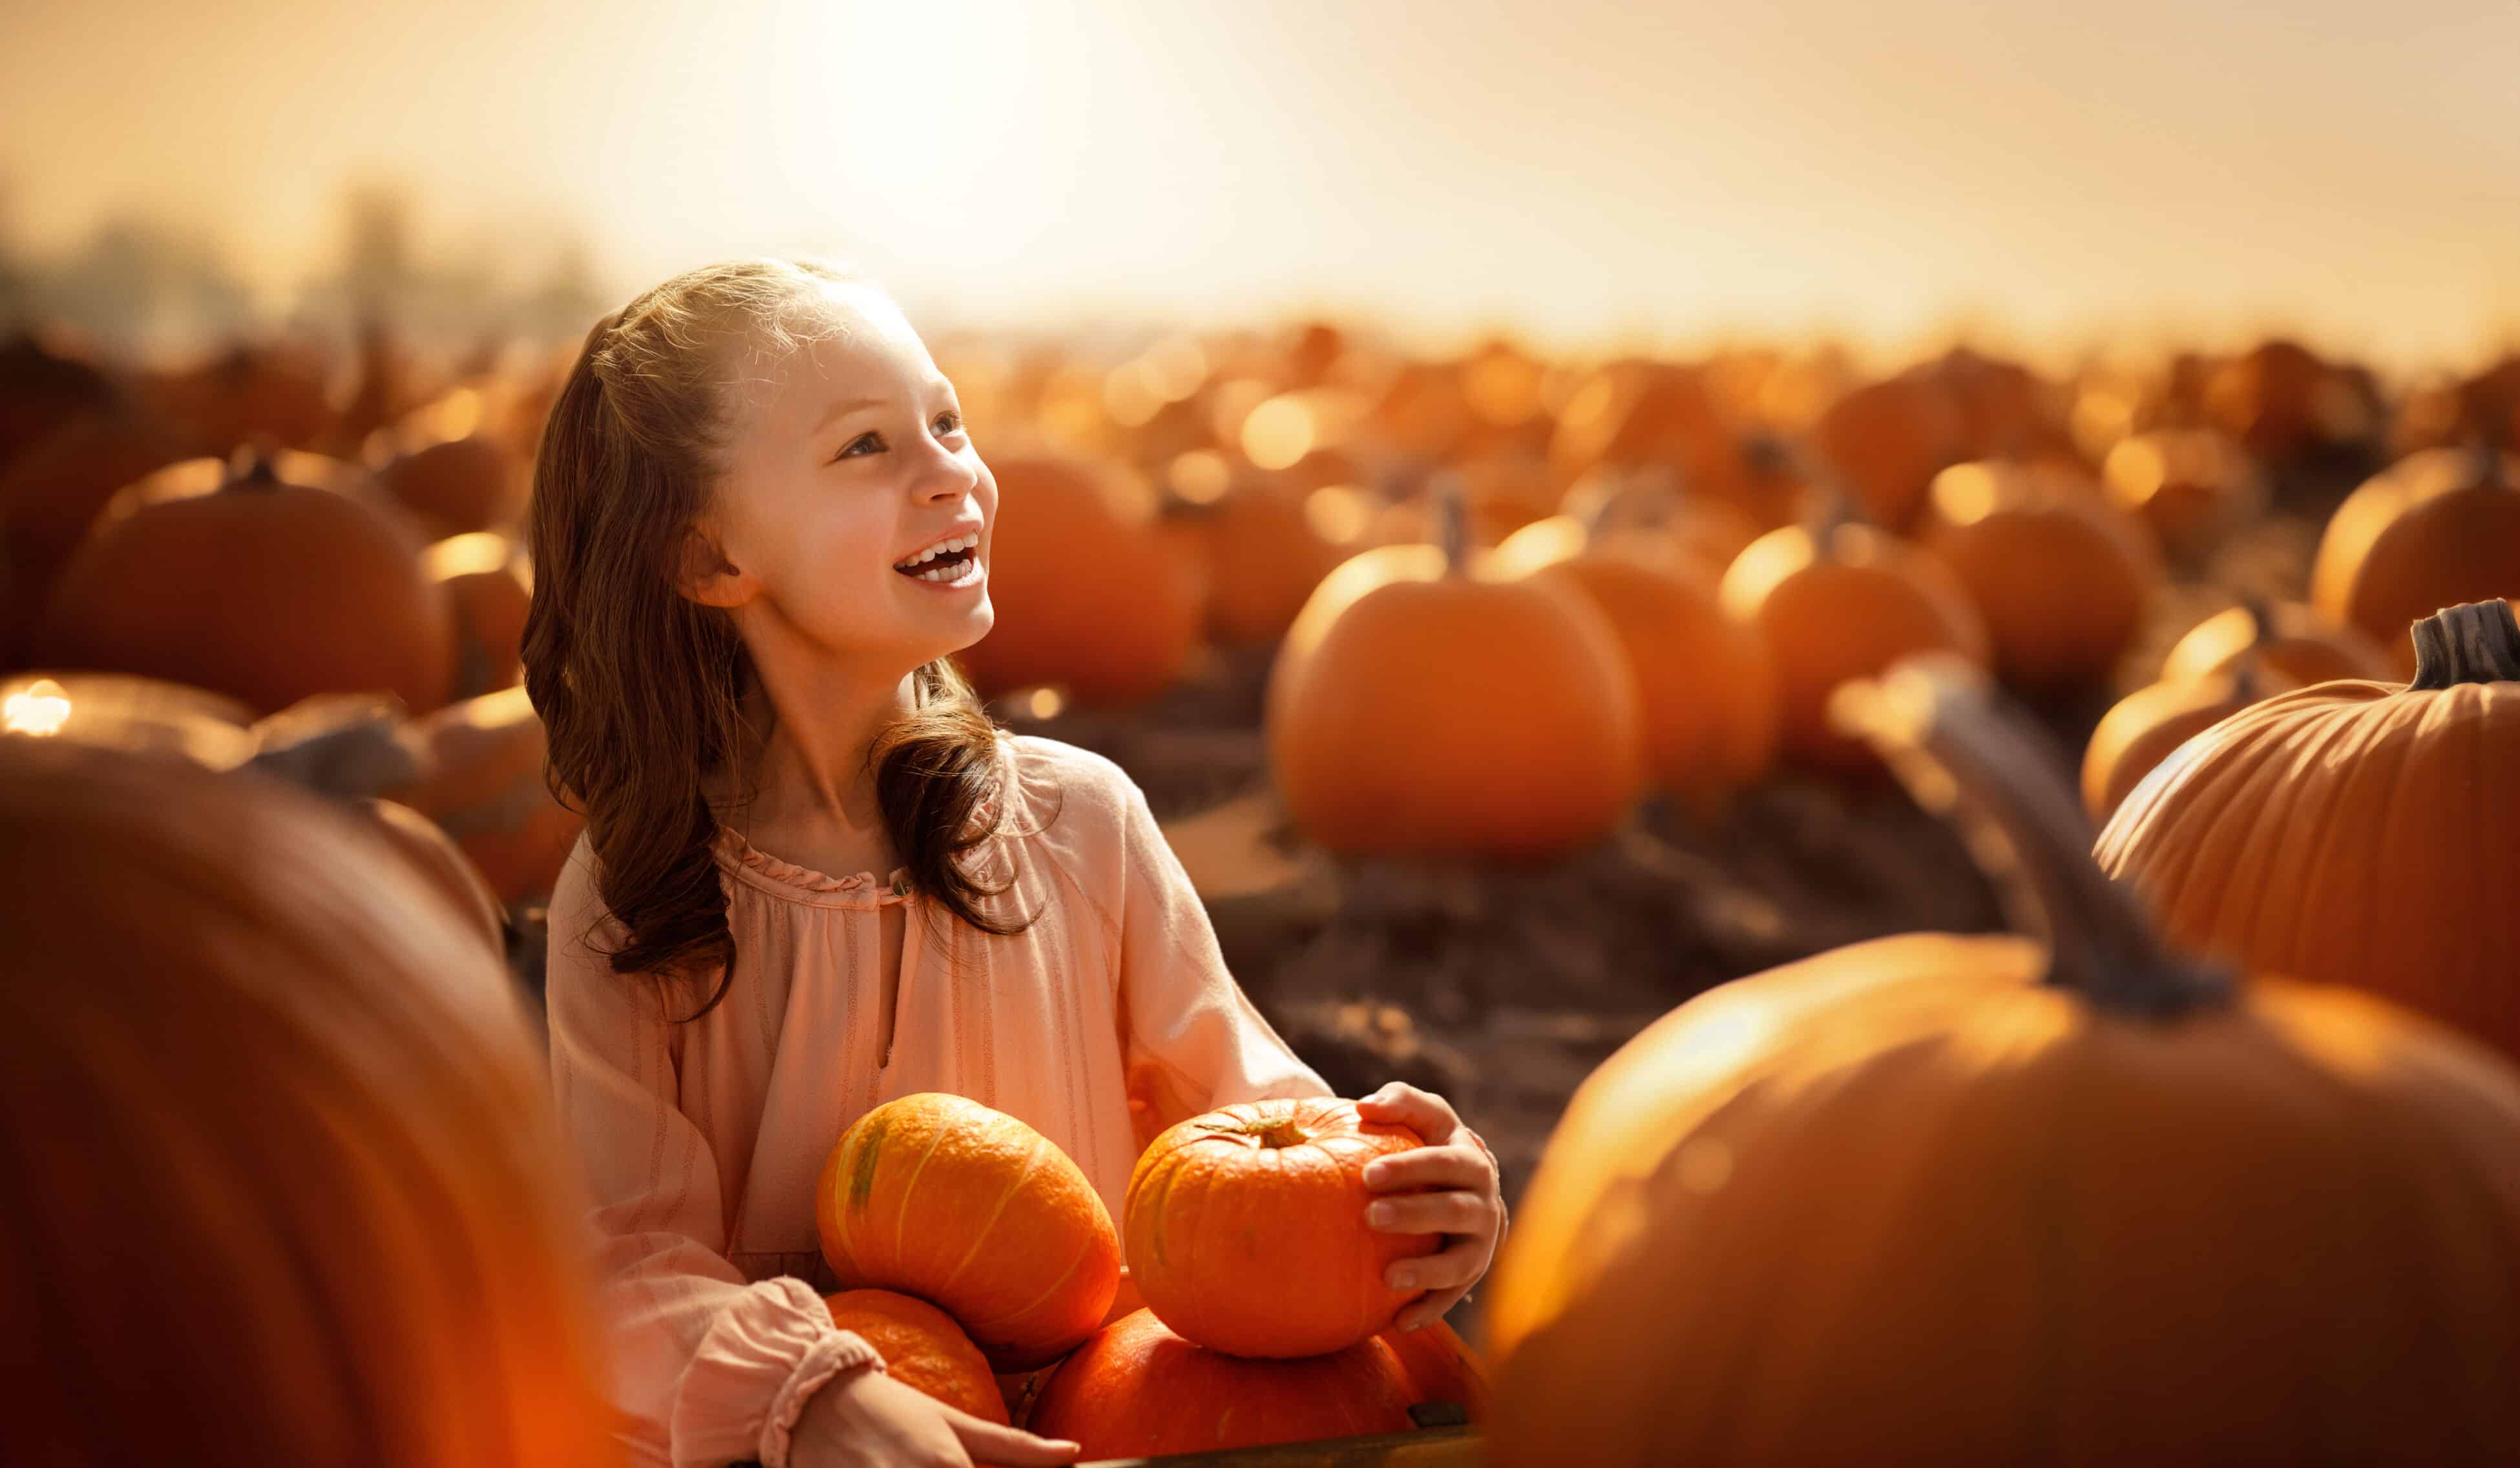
(547, 735), (1328, 1468)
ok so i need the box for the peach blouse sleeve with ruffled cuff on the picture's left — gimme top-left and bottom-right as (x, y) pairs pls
(547, 844), (885, 1468)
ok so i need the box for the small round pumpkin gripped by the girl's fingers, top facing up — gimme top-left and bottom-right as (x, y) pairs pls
(1122, 1098), (1442, 1358)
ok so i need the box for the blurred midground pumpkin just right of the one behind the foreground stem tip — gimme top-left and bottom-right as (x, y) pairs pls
(1920, 461), (2162, 693)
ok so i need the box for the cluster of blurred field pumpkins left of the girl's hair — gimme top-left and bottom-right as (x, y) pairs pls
(0, 332), (580, 929)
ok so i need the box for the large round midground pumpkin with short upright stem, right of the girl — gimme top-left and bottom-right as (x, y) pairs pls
(1265, 486), (1643, 859)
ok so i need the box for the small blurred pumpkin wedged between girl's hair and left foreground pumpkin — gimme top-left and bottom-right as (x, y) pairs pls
(393, 687), (587, 904)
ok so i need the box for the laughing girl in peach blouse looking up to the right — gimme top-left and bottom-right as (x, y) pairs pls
(524, 259), (1504, 1468)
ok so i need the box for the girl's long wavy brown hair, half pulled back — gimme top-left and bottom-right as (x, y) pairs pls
(524, 259), (1023, 1020)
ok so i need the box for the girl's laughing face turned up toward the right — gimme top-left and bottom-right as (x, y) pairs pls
(688, 284), (998, 670)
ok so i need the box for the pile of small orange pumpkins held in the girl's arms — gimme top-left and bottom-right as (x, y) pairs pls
(814, 1093), (1484, 1458)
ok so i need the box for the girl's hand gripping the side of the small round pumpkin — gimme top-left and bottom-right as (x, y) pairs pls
(1356, 1080), (1504, 1330)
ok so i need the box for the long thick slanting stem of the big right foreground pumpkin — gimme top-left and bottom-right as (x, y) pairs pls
(1829, 655), (2231, 1017)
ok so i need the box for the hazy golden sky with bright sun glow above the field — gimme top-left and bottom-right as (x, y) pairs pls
(0, 0), (2520, 365)
